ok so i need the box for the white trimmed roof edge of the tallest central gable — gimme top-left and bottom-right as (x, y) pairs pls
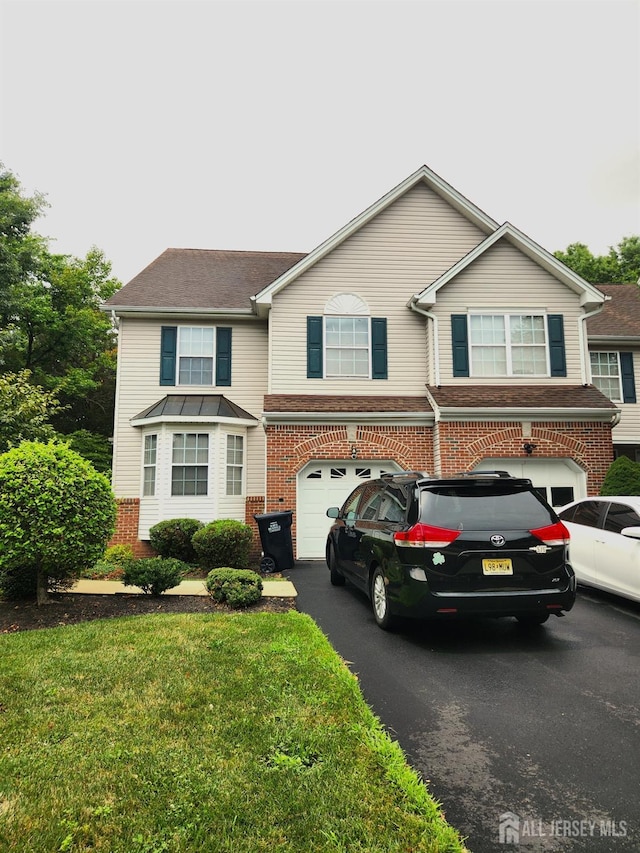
(253, 166), (498, 315)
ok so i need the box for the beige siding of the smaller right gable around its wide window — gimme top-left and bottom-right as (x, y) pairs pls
(433, 240), (583, 385)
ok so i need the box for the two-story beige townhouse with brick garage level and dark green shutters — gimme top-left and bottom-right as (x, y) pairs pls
(104, 167), (640, 559)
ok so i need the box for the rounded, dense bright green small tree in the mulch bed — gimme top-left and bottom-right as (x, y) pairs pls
(0, 441), (116, 604)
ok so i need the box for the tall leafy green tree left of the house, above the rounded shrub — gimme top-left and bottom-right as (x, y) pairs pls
(0, 165), (120, 436)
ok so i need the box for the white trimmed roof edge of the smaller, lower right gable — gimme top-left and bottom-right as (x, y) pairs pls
(411, 222), (610, 311)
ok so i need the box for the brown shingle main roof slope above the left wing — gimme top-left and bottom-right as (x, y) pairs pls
(105, 249), (304, 311)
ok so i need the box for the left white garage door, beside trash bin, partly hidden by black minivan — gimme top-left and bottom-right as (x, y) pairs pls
(296, 460), (401, 560)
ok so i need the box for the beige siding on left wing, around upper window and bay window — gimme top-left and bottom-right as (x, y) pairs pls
(113, 317), (268, 498)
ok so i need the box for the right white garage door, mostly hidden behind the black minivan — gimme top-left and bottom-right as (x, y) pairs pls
(475, 458), (587, 507)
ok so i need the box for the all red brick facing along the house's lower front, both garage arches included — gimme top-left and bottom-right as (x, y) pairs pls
(110, 421), (613, 562)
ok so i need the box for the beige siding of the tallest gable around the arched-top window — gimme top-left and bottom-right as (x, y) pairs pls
(270, 184), (485, 396)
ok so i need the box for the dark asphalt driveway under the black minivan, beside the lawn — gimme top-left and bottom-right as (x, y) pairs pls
(286, 562), (640, 853)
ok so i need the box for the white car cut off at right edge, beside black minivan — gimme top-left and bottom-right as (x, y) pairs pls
(558, 495), (640, 601)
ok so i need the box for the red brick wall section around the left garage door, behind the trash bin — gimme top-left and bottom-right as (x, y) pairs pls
(260, 424), (434, 554)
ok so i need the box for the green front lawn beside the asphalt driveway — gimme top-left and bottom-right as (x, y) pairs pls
(0, 605), (465, 853)
